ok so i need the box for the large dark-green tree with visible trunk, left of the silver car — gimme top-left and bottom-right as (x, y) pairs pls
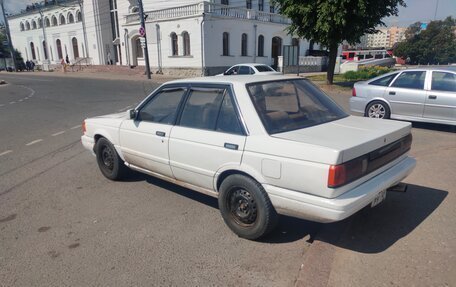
(274, 0), (405, 84)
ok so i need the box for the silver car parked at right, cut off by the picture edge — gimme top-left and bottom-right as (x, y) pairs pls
(350, 67), (456, 125)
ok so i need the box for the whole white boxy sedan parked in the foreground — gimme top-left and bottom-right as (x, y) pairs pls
(81, 76), (415, 239)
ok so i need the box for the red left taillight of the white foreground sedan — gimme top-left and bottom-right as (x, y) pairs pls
(328, 156), (368, 188)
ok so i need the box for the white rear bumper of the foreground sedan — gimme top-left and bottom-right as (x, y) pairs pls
(264, 157), (416, 222)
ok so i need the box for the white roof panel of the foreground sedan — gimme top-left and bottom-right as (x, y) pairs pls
(165, 75), (305, 84)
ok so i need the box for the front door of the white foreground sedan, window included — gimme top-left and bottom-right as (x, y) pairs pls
(119, 87), (187, 177)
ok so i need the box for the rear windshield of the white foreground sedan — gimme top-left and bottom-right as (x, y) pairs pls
(247, 79), (348, 134)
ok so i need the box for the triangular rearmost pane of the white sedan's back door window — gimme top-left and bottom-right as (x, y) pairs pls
(215, 92), (243, 135)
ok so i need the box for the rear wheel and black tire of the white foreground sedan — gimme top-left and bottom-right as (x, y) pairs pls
(218, 174), (278, 240)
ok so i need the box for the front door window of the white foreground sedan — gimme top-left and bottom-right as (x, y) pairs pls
(138, 88), (187, 125)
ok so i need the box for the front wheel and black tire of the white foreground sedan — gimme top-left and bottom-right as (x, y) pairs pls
(95, 138), (128, 180)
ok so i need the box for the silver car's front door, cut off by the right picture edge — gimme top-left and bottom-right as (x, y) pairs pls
(424, 71), (456, 121)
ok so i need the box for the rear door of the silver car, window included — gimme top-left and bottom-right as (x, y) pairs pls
(384, 71), (426, 117)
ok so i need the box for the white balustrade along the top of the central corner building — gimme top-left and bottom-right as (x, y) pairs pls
(125, 2), (291, 24)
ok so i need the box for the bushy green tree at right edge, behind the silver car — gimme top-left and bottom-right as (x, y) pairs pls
(394, 17), (456, 65)
